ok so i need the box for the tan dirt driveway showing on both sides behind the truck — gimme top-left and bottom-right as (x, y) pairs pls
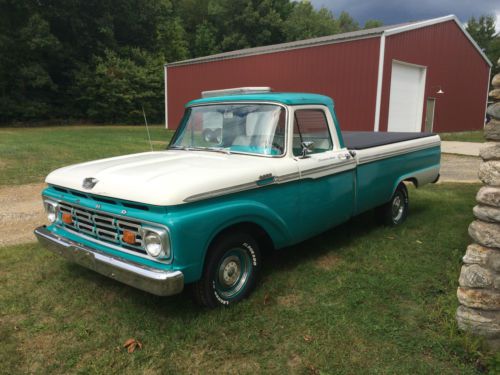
(0, 154), (479, 247)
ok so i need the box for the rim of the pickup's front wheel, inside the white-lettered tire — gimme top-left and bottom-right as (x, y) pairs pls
(215, 249), (251, 299)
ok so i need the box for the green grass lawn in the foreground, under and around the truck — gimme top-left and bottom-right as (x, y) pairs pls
(0, 184), (499, 374)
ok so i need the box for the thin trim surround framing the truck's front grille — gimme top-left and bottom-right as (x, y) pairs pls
(43, 196), (174, 264)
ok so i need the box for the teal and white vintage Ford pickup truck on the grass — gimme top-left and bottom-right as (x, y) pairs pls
(35, 88), (441, 308)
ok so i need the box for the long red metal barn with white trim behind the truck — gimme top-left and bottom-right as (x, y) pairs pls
(165, 16), (491, 132)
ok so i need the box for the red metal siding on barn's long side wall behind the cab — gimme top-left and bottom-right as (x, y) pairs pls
(167, 37), (380, 130)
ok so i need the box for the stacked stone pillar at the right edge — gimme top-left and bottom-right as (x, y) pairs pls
(457, 60), (500, 349)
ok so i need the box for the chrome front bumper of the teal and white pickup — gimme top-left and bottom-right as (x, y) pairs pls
(35, 226), (184, 296)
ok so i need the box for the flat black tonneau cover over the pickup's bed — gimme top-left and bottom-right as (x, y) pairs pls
(342, 132), (435, 150)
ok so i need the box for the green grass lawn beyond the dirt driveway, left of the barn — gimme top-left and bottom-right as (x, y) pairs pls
(0, 125), (173, 186)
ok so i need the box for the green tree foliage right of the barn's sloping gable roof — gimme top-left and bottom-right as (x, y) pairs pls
(467, 16), (500, 76)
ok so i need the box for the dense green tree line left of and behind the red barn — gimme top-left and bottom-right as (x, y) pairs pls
(0, 0), (378, 123)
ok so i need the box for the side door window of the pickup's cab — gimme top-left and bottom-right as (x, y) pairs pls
(293, 109), (333, 156)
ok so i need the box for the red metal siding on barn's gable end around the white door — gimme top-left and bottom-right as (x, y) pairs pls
(380, 21), (489, 132)
